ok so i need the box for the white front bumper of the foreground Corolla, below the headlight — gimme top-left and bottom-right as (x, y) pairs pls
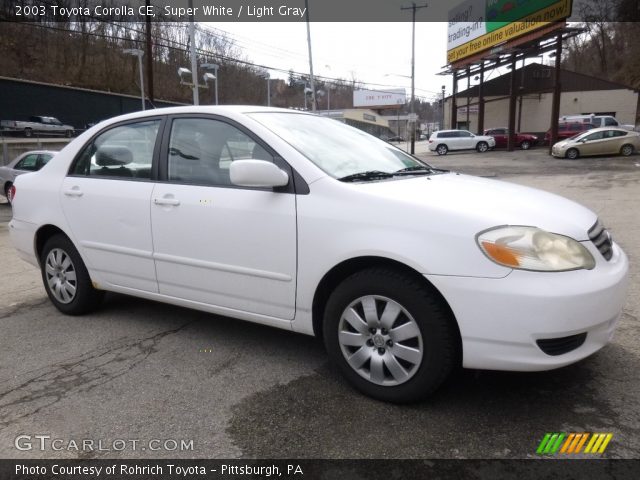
(426, 242), (629, 371)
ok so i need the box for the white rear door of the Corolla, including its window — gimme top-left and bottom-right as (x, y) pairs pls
(60, 117), (163, 292)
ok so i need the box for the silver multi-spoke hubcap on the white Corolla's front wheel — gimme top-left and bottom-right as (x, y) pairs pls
(338, 295), (423, 386)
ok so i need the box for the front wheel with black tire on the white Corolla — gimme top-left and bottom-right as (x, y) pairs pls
(323, 268), (458, 403)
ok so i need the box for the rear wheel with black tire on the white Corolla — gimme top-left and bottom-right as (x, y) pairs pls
(40, 234), (104, 315)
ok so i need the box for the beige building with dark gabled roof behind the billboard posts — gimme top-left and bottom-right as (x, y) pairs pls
(445, 63), (638, 133)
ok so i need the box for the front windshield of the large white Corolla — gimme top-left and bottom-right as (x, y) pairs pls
(249, 112), (431, 179)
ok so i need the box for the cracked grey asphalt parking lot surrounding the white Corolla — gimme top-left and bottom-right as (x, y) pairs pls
(0, 148), (640, 458)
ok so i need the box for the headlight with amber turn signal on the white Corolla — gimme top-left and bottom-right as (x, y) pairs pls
(476, 226), (596, 272)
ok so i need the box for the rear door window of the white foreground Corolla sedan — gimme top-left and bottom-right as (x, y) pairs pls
(71, 120), (160, 180)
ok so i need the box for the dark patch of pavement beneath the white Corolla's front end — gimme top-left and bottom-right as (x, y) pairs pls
(224, 318), (640, 458)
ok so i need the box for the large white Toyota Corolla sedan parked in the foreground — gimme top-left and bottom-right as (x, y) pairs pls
(10, 107), (628, 402)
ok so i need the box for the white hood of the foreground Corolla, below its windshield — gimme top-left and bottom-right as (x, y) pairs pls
(353, 173), (597, 241)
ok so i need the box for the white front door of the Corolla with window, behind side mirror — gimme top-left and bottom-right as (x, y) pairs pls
(151, 117), (297, 320)
